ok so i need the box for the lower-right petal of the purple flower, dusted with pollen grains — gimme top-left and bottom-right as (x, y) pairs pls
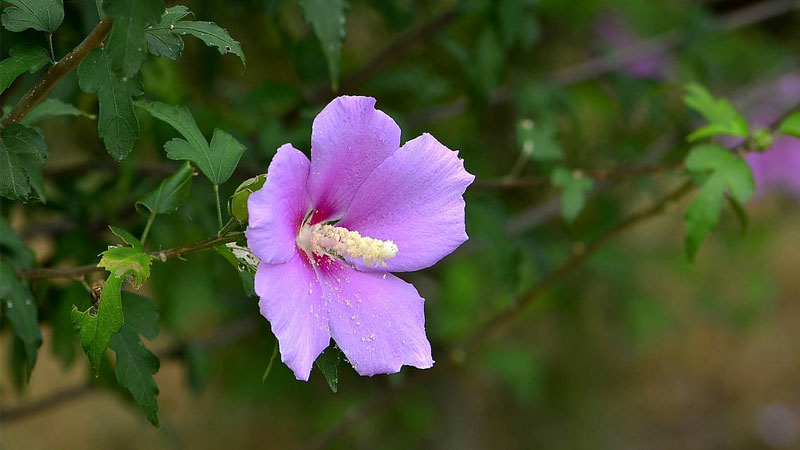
(318, 260), (433, 376)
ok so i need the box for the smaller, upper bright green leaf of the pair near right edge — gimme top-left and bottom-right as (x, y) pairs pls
(683, 83), (748, 141)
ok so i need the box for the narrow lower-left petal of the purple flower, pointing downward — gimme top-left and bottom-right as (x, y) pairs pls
(255, 252), (331, 381)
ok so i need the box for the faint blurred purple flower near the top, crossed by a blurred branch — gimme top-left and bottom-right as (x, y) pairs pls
(594, 12), (673, 80)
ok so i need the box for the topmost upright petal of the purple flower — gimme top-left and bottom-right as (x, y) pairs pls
(308, 96), (400, 220)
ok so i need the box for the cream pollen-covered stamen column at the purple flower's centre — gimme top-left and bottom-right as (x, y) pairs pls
(295, 220), (397, 267)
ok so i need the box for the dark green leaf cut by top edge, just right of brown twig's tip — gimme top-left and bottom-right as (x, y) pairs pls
(103, 0), (164, 79)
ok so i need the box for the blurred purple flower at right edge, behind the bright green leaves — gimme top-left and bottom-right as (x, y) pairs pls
(743, 73), (800, 201)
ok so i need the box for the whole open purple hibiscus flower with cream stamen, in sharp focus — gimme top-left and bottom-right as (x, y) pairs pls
(246, 97), (475, 380)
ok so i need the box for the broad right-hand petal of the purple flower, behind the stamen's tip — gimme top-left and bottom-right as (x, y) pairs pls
(338, 134), (475, 272)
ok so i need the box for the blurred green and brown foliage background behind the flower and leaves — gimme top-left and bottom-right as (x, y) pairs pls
(0, 0), (800, 450)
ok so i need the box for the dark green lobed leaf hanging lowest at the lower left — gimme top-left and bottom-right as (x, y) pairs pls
(109, 294), (160, 426)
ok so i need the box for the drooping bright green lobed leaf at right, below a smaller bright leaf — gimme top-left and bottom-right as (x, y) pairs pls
(685, 145), (755, 260)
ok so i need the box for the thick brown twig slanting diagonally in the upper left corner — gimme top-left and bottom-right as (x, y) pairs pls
(0, 18), (112, 129)
